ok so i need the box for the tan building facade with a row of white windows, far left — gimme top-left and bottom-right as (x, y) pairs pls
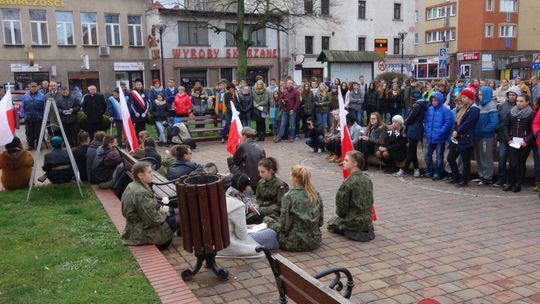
(0, 0), (152, 93)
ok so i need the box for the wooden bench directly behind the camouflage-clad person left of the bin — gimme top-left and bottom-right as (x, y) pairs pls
(118, 149), (177, 202)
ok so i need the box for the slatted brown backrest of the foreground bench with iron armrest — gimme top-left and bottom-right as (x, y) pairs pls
(273, 254), (350, 304)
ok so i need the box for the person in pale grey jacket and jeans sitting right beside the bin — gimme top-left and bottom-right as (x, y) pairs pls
(218, 173), (279, 258)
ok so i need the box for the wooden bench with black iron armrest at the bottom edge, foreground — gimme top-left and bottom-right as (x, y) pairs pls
(256, 247), (354, 304)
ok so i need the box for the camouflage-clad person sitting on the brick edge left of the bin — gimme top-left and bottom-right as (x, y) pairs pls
(122, 162), (179, 249)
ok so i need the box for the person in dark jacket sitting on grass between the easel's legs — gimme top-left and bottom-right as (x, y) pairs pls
(42, 136), (73, 184)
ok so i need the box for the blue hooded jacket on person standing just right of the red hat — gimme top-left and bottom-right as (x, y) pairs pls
(474, 86), (499, 141)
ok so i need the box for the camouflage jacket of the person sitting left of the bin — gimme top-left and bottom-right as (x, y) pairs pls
(122, 181), (173, 245)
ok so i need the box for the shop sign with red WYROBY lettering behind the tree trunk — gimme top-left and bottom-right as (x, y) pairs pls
(172, 48), (277, 59)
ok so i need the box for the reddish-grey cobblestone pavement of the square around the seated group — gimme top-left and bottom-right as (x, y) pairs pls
(165, 138), (540, 304)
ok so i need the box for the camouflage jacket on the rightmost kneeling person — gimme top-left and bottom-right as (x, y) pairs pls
(328, 171), (373, 234)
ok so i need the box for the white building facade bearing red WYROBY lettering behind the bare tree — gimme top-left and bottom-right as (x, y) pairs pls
(143, 4), (288, 87)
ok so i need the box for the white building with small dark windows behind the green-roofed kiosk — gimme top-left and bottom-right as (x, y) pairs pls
(289, 0), (415, 82)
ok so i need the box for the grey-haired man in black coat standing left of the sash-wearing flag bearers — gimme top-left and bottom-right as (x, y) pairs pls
(82, 86), (107, 137)
